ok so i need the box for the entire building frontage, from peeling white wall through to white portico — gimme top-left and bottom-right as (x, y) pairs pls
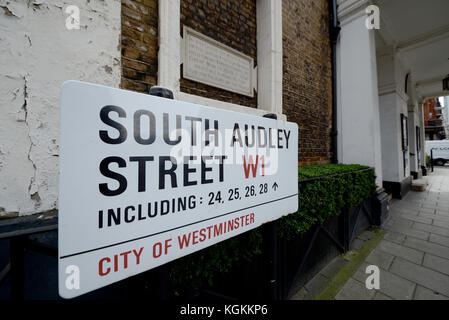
(0, 0), (449, 216)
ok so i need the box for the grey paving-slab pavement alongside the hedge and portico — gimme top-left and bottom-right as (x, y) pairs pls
(335, 167), (449, 300)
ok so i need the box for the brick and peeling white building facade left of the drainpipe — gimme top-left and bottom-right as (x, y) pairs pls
(0, 0), (333, 216)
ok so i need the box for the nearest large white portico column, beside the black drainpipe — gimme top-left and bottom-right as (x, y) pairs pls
(337, 1), (382, 187)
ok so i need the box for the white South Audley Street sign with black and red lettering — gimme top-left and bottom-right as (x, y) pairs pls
(58, 81), (298, 298)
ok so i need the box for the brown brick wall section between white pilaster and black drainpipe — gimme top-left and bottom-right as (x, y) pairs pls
(282, 0), (332, 165)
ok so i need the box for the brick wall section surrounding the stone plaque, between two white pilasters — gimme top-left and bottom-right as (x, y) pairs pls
(180, 0), (257, 108)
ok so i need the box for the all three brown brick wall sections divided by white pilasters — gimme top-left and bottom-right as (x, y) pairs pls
(117, 0), (332, 165)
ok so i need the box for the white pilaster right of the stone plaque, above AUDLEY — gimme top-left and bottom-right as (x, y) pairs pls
(257, 0), (282, 114)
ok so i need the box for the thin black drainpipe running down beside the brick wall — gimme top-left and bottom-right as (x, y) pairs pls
(329, 0), (341, 163)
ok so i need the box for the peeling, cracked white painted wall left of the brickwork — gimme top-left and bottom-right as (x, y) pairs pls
(0, 0), (120, 216)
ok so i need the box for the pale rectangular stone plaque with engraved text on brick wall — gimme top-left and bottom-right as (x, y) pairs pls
(182, 26), (255, 97)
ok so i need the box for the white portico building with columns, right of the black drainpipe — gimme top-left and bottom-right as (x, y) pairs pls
(334, 0), (449, 198)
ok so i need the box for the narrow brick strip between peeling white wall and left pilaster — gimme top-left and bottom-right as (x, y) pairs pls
(120, 0), (158, 92)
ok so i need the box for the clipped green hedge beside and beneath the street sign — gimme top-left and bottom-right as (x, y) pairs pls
(171, 164), (376, 293)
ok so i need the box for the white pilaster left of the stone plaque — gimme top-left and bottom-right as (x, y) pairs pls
(157, 0), (181, 96)
